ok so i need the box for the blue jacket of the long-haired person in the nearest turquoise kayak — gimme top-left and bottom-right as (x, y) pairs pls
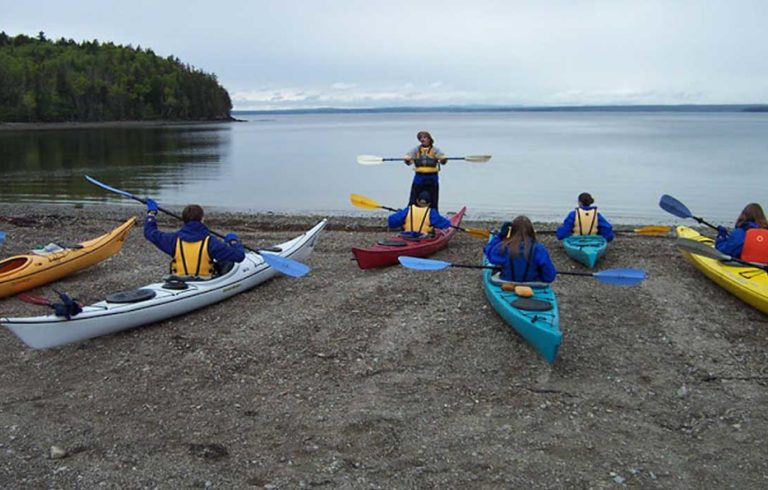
(483, 235), (557, 282)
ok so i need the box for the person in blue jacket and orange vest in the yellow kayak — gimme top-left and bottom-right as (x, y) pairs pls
(715, 202), (768, 264)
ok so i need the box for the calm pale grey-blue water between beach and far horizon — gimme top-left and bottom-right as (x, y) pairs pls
(0, 112), (768, 224)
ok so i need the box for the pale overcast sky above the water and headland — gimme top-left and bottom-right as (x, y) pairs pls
(0, 0), (768, 109)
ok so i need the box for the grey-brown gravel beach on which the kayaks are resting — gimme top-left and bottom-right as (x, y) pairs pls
(0, 204), (768, 489)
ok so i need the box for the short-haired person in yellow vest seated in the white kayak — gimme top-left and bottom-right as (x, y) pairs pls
(144, 199), (245, 279)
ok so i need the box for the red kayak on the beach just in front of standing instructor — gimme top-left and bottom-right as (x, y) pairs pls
(352, 207), (467, 269)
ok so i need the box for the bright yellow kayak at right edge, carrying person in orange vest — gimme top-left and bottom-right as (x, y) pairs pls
(676, 226), (768, 314)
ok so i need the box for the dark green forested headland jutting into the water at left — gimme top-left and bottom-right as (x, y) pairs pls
(0, 32), (232, 122)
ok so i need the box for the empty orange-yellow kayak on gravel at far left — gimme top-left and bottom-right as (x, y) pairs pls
(0, 218), (136, 298)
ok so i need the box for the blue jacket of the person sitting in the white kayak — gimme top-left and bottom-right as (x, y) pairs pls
(144, 215), (245, 262)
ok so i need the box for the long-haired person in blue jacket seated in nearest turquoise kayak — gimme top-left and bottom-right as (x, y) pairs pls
(483, 215), (557, 282)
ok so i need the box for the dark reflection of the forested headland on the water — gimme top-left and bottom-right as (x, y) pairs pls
(0, 124), (230, 203)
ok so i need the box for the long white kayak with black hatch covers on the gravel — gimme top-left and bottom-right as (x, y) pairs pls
(0, 219), (327, 349)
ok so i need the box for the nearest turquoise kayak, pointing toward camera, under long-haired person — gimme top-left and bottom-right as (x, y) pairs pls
(483, 270), (563, 364)
